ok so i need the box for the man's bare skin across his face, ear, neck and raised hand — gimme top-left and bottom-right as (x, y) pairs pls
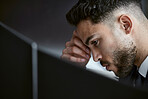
(61, 14), (148, 77)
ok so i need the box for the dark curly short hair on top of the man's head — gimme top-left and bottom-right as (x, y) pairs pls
(66, 0), (142, 26)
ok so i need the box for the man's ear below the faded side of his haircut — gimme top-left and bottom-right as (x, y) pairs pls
(119, 15), (132, 34)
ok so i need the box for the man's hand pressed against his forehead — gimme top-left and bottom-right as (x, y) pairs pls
(61, 31), (91, 66)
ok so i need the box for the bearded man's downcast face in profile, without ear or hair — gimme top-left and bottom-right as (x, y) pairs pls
(77, 20), (136, 77)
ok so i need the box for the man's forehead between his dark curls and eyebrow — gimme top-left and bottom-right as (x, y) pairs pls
(77, 20), (108, 43)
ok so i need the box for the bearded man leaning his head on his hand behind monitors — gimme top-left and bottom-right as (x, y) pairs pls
(62, 0), (148, 87)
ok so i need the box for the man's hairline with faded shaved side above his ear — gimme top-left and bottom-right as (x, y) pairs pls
(76, 3), (146, 26)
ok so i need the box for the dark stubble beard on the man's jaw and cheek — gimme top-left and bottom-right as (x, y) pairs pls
(113, 41), (137, 78)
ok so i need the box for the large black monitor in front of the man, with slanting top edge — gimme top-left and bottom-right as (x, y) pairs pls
(38, 48), (148, 99)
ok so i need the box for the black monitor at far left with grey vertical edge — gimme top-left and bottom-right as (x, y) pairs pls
(0, 22), (37, 99)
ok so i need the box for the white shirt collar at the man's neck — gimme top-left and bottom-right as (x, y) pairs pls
(139, 56), (148, 78)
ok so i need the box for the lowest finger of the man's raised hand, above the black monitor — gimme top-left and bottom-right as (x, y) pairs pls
(62, 54), (86, 63)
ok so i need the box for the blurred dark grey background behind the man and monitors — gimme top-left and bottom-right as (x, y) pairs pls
(0, 0), (148, 57)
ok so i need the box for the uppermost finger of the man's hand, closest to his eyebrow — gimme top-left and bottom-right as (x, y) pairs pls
(73, 38), (90, 54)
